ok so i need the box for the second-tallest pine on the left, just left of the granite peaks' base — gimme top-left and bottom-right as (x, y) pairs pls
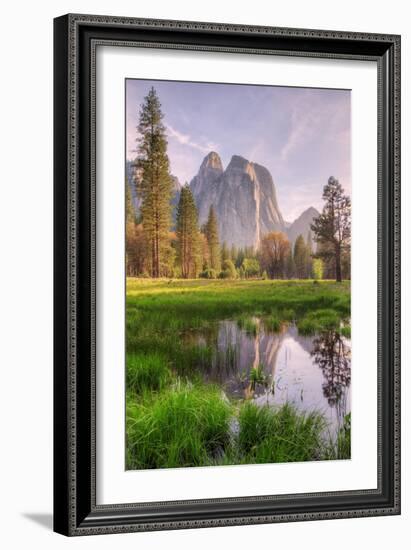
(176, 183), (202, 279)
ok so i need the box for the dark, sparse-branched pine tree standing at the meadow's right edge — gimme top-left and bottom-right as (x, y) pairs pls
(311, 176), (351, 283)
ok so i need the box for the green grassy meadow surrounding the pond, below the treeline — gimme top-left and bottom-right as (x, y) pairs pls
(126, 278), (350, 469)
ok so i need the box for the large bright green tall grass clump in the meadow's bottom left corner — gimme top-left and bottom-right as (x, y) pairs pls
(127, 383), (231, 469)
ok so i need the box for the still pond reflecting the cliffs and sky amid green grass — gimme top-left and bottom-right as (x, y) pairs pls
(182, 317), (351, 432)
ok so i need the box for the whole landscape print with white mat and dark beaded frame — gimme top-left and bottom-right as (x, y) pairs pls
(54, 15), (400, 536)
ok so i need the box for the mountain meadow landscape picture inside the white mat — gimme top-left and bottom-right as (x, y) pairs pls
(124, 78), (352, 470)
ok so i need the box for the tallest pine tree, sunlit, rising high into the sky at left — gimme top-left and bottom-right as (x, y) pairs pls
(136, 88), (173, 277)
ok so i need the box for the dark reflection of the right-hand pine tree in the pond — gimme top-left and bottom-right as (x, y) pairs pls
(311, 330), (351, 419)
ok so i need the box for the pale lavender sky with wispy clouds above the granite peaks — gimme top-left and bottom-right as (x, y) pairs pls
(126, 79), (351, 222)
